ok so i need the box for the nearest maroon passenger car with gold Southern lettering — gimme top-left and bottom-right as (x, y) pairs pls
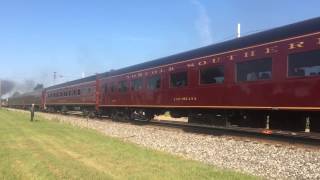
(99, 18), (320, 130)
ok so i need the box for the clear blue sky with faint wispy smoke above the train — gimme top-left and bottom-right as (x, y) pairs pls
(0, 0), (320, 86)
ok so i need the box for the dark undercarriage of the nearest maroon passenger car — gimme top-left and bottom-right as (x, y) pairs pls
(99, 108), (320, 133)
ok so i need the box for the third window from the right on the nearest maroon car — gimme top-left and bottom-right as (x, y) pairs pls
(200, 66), (224, 84)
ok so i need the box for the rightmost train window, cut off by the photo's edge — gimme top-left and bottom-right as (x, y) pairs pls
(288, 50), (320, 77)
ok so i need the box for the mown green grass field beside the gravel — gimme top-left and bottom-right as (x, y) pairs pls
(0, 110), (255, 179)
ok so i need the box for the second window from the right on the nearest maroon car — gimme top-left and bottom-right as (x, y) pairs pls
(237, 58), (272, 82)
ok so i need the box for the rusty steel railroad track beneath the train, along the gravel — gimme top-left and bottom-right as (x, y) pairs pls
(62, 109), (320, 146)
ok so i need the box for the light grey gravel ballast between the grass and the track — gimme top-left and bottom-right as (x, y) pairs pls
(11, 109), (320, 179)
